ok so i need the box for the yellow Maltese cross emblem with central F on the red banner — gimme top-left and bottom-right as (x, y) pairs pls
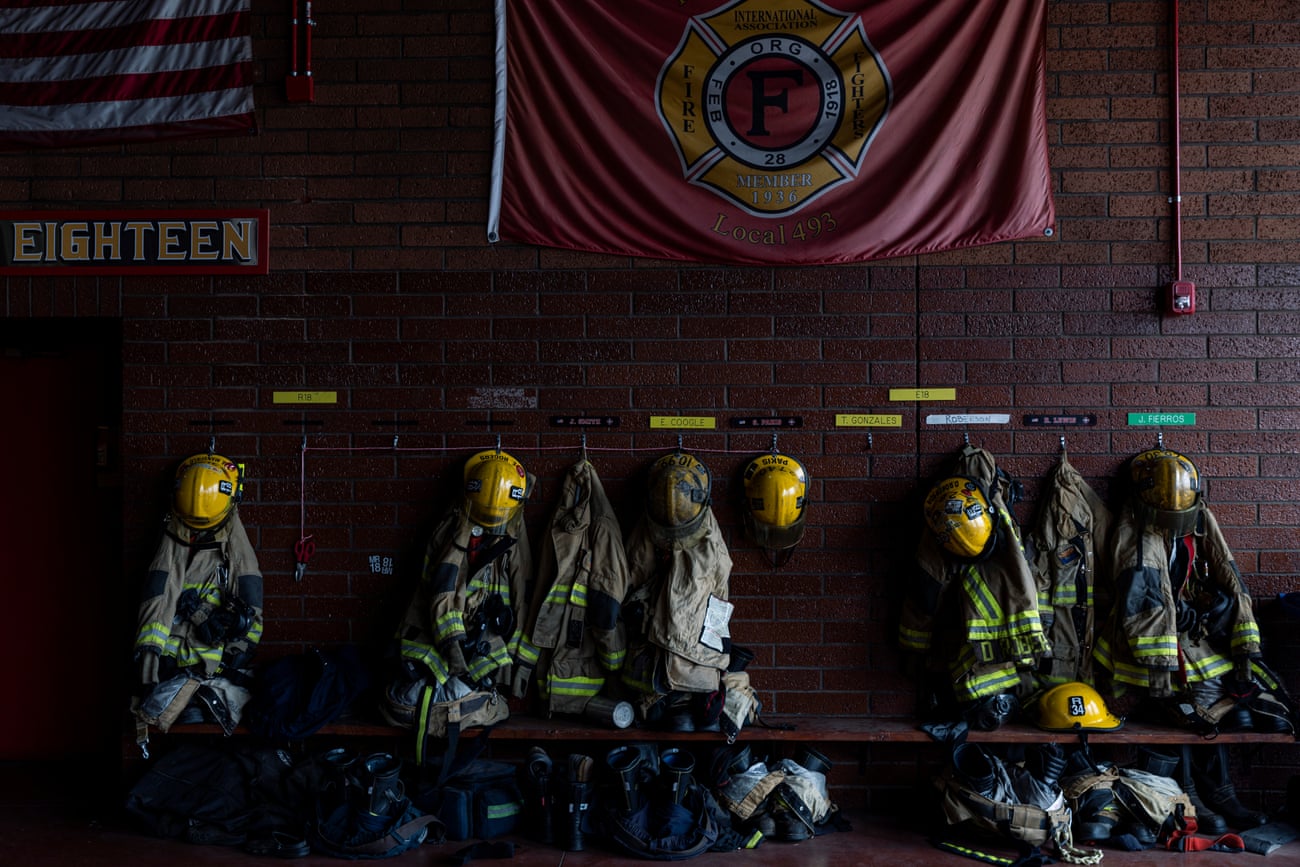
(657, 0), (893, 217)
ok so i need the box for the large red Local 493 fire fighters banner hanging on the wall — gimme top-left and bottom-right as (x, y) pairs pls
(488, 0), (1056, 265)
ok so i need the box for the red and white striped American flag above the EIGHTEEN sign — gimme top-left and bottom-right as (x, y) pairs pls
(0, 0), (256, 149)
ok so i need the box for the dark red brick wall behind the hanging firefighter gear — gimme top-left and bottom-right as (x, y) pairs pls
(0, 0), (1300, 805)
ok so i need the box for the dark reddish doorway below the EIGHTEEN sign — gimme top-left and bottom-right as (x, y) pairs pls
(0, 318), (122, 760)
